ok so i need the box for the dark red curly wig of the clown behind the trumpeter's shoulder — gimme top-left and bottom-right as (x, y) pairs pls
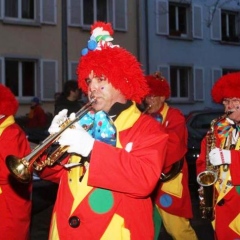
(145, 72), (170, 99)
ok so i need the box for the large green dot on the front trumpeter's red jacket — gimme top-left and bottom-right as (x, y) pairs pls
(88, 189), (114, 214)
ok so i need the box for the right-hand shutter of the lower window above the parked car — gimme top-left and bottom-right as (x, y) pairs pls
(194, 67), (205, 101)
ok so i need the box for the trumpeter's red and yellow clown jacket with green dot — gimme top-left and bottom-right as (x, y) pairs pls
(38, 104), (168, 240)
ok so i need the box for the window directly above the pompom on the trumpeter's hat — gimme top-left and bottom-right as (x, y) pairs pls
(83, 0), (108, 25)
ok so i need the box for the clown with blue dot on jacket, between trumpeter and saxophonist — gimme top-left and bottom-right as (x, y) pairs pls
(145, 73), (197, 240)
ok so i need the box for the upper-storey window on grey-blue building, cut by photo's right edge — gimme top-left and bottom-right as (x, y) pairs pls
(221, 11), (240, 42)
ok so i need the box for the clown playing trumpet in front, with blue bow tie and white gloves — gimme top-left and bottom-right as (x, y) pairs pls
(38, 22), (168, 240)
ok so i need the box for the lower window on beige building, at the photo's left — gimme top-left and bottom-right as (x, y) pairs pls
(5, 59), (36, 97)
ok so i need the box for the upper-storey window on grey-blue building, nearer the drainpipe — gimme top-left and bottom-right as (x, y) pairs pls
(169, 3), (190, 37)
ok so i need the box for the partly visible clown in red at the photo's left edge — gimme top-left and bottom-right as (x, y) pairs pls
(0, 84), (32, 240)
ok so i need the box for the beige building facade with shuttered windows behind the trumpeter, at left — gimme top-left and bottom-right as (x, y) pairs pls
(0, 0), (138, 114)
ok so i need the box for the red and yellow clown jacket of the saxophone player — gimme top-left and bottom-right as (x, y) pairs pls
(196, 120), (240, 240)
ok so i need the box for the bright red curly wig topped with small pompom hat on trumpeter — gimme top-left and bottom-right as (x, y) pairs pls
(77, 22), (149, 103)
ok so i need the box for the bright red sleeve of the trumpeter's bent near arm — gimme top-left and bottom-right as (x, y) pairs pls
(88, 118), (168, 198)
